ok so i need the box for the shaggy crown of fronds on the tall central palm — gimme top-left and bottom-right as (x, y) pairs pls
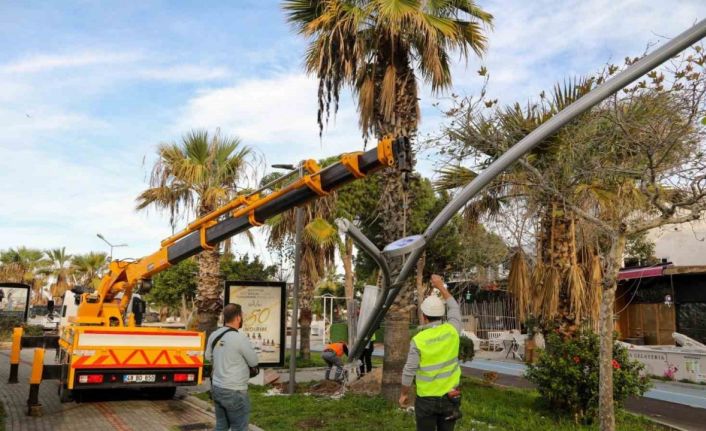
(284, 0), (493, 135)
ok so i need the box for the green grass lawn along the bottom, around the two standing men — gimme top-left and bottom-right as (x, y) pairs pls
(196, 378), (666, 431)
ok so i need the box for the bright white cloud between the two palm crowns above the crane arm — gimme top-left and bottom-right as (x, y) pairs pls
(175, 72), (363, 161)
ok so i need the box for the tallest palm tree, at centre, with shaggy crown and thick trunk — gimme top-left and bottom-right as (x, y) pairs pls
(284, 0), (493, 401)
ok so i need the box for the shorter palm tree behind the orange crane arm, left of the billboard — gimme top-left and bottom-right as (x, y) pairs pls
(137, 130), (251, 333)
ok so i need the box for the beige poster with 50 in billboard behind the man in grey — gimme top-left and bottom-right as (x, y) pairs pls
(225, 281), (287, 367)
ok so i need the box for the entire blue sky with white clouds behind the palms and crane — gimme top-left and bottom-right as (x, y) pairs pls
(0, 0), (706, 262)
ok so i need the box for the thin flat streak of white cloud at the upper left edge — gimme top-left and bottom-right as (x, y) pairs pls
(0, 51), (141, 73)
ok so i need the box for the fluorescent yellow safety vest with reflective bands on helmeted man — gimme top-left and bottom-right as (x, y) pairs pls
(413, 323), (461, 397)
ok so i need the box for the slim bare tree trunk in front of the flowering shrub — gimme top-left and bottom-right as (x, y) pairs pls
(598, 233), (626, 431)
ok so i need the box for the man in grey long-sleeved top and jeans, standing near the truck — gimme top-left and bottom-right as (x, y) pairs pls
(206, 304), (257, 431)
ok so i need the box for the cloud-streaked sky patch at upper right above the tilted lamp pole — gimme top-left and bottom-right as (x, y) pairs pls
(446, 0), (706, 103)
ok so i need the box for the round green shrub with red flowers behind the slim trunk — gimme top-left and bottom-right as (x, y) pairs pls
(526, 330), (650, 423)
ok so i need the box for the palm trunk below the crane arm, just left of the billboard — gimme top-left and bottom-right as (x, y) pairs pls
(194, 249), (223, 337)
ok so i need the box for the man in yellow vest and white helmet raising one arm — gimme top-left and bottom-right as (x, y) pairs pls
(399, 274), (462, 431)
